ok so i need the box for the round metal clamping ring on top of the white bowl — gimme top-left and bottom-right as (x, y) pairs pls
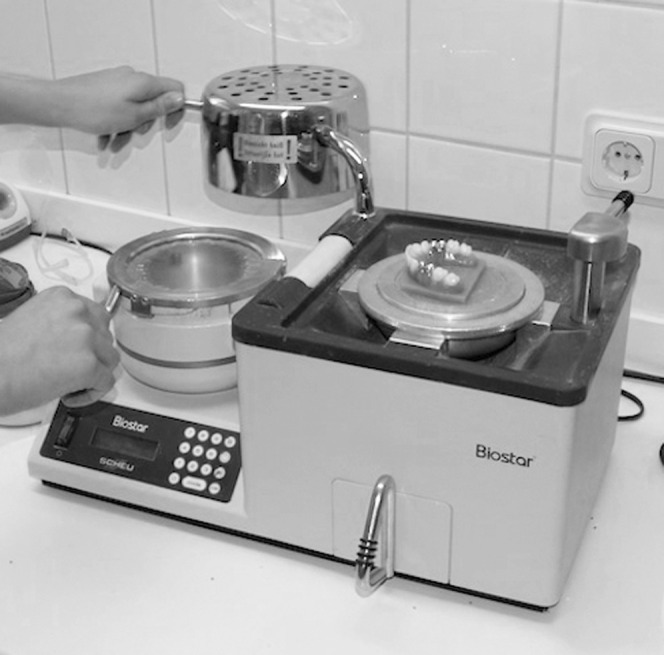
(106, 228), (286, 307)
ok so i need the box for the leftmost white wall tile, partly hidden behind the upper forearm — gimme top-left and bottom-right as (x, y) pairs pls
(0, 0), (65, 192)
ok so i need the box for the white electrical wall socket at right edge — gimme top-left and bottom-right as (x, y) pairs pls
(581, 114), (664, 206)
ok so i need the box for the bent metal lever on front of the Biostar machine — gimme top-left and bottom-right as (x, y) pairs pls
(355, 475), (396, 597)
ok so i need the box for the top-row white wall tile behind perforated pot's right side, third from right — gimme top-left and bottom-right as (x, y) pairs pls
(274, 0), (407, 130)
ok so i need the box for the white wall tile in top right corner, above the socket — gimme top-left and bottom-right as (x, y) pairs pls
(556, 1), (664, 158)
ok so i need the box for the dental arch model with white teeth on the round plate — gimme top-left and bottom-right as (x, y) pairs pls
(404, 239), (477, 289)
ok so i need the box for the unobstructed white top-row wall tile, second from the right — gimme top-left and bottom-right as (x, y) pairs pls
(409, 0), (559, 153)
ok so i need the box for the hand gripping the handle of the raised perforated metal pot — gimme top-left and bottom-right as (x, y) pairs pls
(54, 66), (184, 151)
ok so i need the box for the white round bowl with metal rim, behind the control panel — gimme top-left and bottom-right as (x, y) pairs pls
(107, 228), (286, 393)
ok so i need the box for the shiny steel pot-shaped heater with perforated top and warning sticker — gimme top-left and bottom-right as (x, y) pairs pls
(192, 65), (369, 212)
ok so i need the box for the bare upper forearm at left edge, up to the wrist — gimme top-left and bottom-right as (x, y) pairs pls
(0, 75), (67, 127)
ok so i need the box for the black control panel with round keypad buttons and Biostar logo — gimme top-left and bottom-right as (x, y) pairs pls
(40, 402), (241, 502)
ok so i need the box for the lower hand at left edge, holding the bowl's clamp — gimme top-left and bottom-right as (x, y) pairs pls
(0, 287), (119, 415)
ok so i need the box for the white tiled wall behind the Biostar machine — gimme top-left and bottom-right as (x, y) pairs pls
(0, 0), (664, 362)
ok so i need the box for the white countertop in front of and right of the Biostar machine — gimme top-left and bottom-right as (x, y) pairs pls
(0, 380), (664, 655)
